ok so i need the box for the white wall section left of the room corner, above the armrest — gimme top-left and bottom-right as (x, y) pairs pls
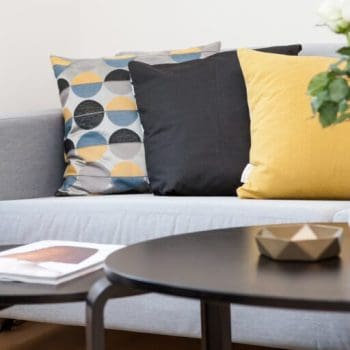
(0, 0), (80, 113)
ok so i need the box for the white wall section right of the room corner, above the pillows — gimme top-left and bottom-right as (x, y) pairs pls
(81, 0), (339, 56)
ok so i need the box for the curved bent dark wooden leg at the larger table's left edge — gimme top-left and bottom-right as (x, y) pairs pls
(86, 278), (144, 350)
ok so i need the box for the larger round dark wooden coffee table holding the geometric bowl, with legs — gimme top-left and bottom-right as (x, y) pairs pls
(87, 224), (350, 350)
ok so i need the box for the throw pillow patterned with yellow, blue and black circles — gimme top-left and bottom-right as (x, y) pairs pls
(51, 42), (220, 195)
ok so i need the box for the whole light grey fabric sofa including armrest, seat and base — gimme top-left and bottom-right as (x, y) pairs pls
(0, 44), (350, 350)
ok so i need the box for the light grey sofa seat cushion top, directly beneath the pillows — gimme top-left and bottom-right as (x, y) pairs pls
(0, 194), (350, 244)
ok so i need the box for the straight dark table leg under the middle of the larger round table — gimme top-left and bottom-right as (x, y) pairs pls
(201, 300), (232, 350)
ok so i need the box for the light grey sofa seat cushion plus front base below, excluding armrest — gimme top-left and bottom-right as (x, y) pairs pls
(0, 194), (350, 350)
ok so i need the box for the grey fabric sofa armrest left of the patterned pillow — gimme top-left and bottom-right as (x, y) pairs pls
(0, 109), (64, 200)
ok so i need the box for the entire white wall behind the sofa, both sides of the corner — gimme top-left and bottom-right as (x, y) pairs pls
(0, 0), (341, 112)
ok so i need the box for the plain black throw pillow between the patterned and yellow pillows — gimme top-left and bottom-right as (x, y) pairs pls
(129, 45), (301, 196)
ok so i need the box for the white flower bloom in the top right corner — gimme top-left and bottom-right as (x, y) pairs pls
(318, 0), (350, 33)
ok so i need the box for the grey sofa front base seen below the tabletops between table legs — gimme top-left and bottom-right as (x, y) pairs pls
(0, 294), (350, 350)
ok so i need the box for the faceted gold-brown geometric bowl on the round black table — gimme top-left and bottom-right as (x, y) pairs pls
(255, 224), (343, 261)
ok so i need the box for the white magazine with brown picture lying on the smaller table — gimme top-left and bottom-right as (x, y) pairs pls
(0, 241), (123, 284)
